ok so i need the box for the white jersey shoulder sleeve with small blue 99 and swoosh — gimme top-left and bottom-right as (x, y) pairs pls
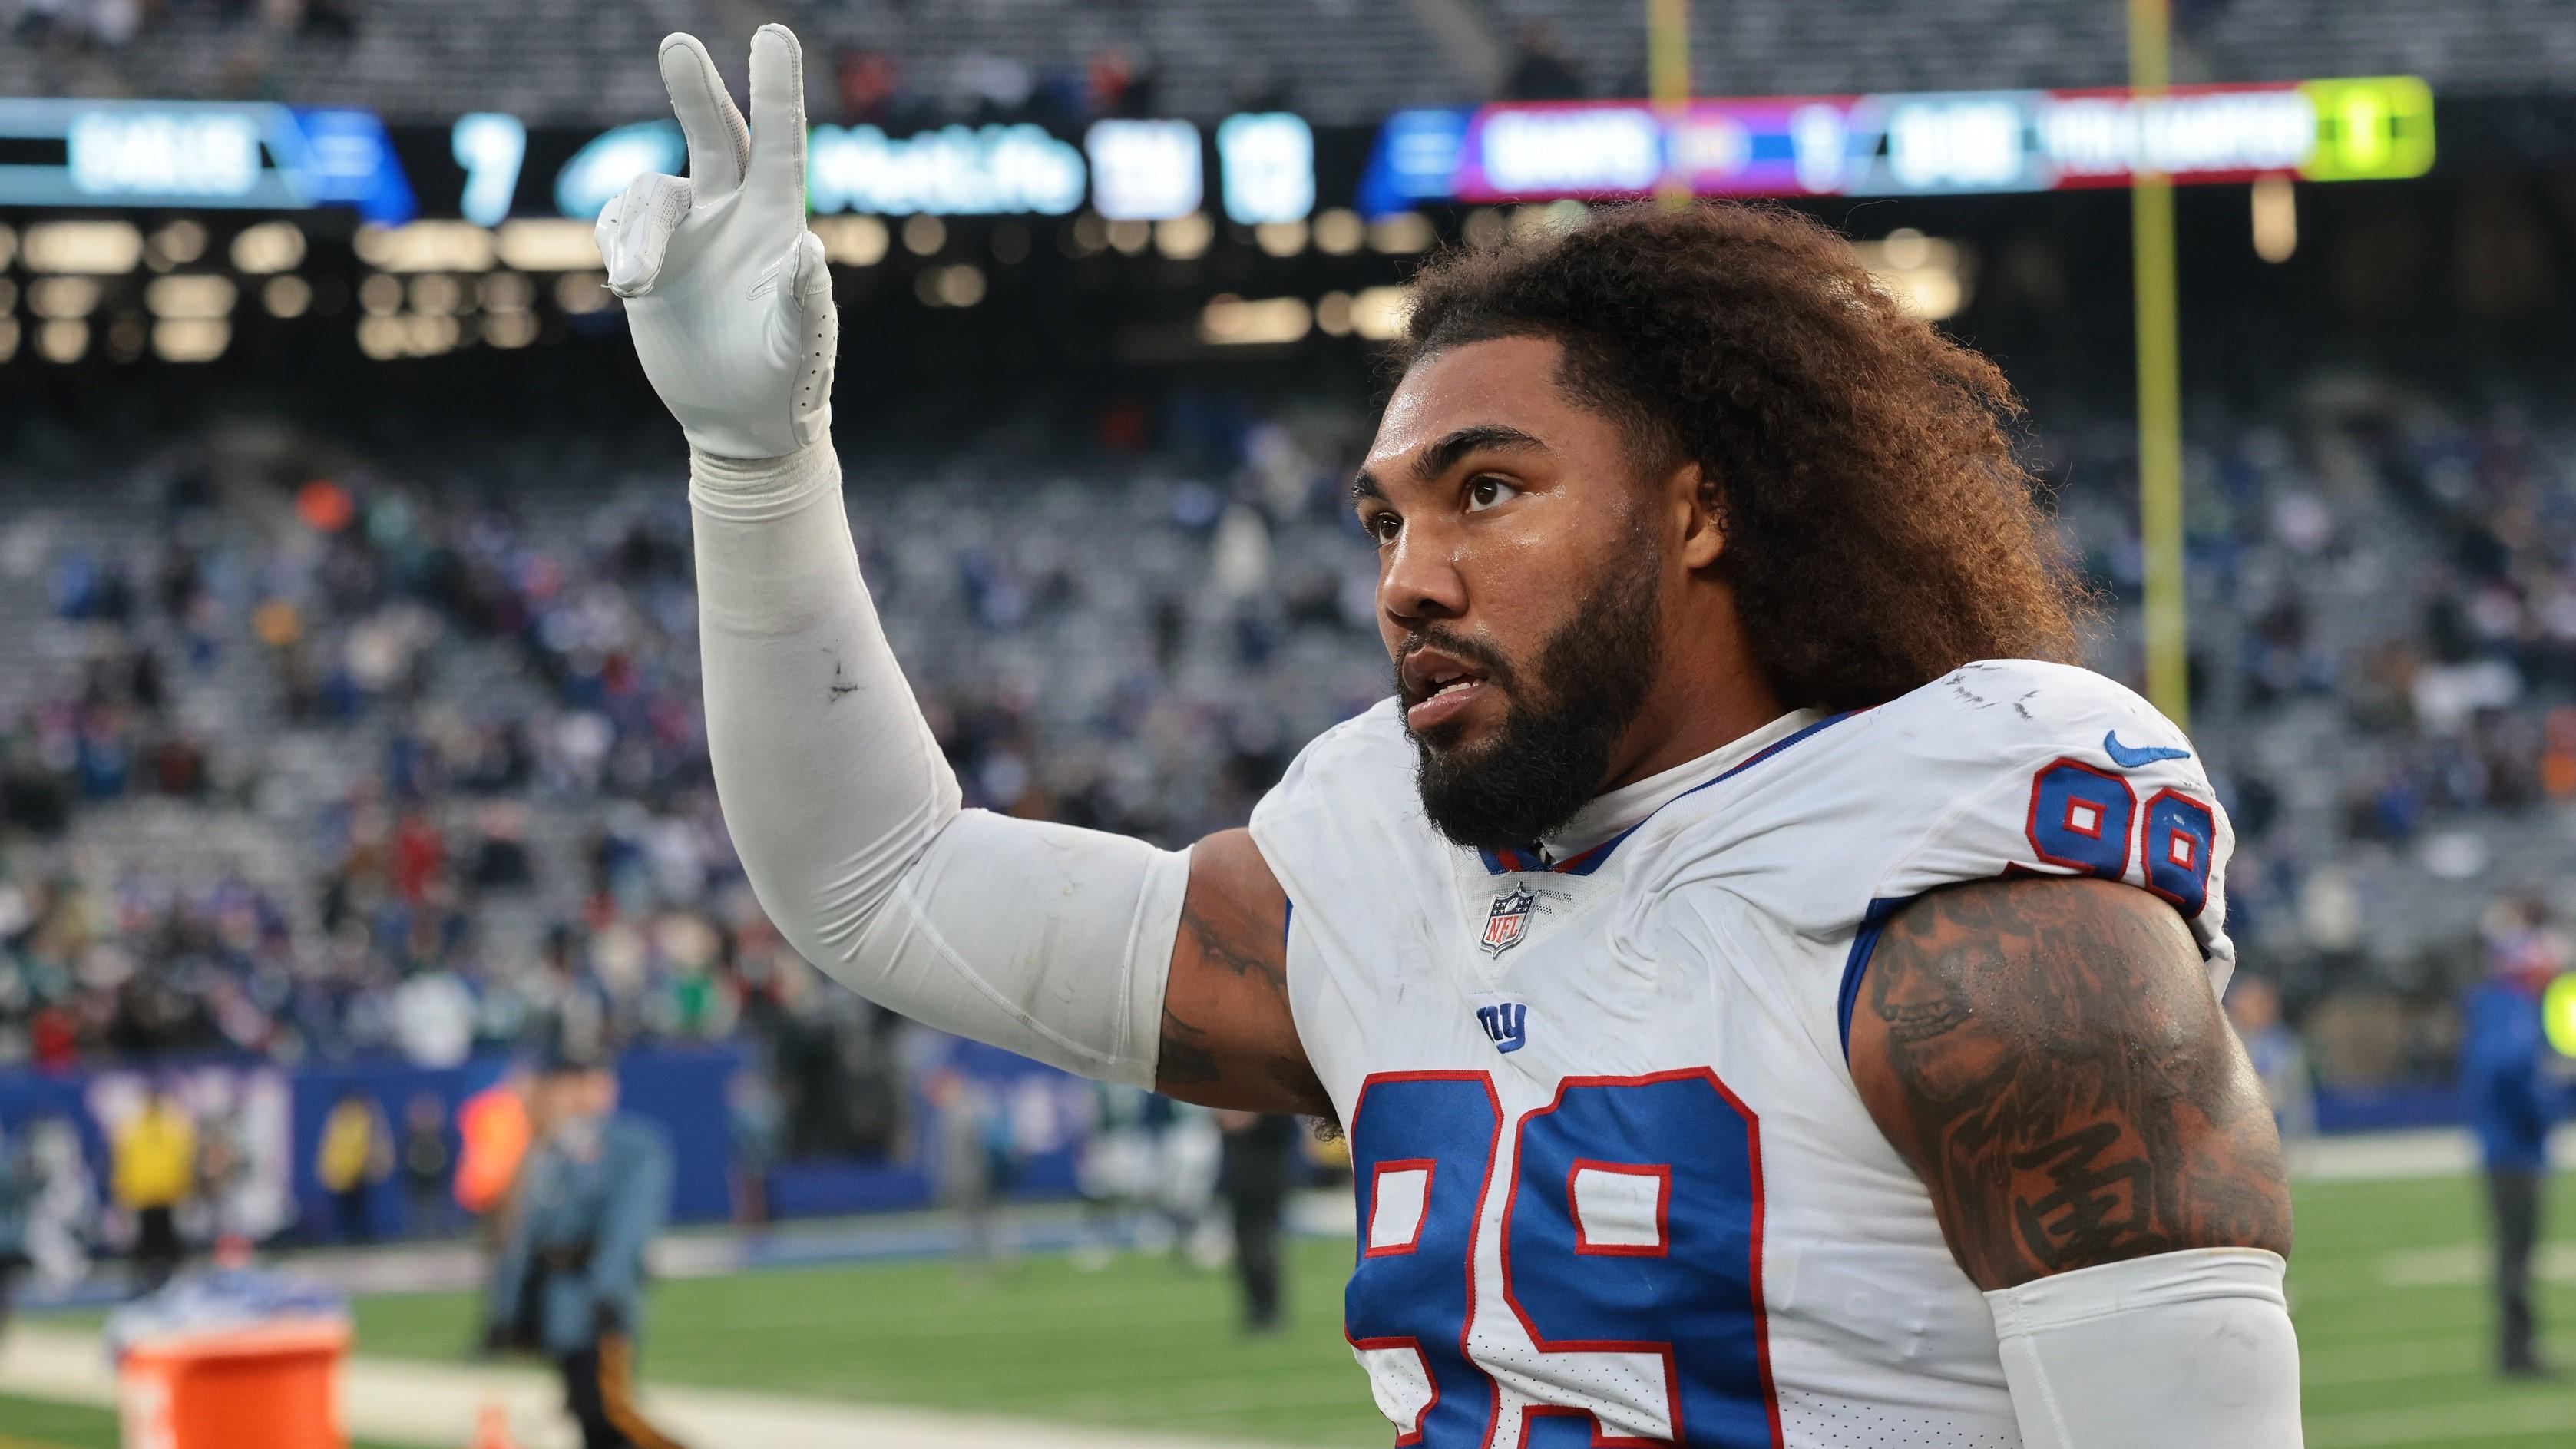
(1873, 660), (2236, 974)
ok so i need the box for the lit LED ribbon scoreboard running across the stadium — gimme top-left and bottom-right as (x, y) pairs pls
(0, 78), (2434, 227)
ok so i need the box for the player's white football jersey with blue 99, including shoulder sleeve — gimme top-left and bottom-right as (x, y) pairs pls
(1252, 660), (2234, 1449)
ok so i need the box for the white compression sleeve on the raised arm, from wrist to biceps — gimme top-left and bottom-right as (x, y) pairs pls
(688, 438), (1190, 1086)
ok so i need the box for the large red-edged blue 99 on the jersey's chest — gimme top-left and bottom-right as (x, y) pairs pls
(1344, 1070), (1780, 1449)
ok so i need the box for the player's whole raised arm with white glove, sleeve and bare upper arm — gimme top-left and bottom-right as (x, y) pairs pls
(613, 26), (1321, 1109)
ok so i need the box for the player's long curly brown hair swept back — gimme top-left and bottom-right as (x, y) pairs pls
(1396, 203), (2089, 709)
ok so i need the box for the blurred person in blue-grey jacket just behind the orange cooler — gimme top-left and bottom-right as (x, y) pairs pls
(487, 1041), (673, 1449)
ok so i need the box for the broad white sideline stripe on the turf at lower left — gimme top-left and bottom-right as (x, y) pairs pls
(0, 1325), (1298, 1449)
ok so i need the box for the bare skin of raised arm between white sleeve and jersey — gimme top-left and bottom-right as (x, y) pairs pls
(1154, 830), (1332, 1117)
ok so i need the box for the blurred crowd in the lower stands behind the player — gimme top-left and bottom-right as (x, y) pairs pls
(0, 369), (2576, 1103)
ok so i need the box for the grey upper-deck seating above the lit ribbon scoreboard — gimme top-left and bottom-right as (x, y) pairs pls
(0, 0), (2576, 124)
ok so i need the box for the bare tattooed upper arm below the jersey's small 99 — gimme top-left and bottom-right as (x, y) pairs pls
(1852, 879), (2290, 1289)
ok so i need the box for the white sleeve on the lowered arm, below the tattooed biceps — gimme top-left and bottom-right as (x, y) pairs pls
(1986, 1248), (2303, 1449)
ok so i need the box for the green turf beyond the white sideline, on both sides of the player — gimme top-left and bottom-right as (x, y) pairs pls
(296, 1178), (2576, 1449)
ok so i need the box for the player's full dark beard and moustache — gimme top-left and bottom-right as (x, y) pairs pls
(1396, 547), (1662, 849)
